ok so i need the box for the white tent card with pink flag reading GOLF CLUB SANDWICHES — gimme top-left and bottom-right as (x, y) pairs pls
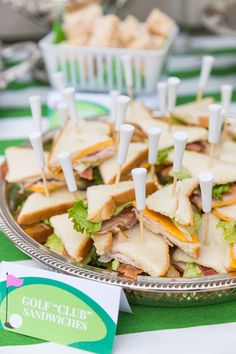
(0, 262), (130, 354)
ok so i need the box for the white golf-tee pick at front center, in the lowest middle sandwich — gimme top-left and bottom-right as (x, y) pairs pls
(132, 168), (147, 242)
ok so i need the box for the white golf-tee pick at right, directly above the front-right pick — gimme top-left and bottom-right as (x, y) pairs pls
(208, 104), (222, 167)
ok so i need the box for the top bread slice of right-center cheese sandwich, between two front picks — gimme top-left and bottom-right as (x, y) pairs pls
(146, 178), (198, 225)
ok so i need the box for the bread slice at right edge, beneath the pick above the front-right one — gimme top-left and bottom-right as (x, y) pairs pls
(168, 151), (236, 184)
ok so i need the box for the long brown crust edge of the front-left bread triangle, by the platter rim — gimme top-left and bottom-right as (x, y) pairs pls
(17, 202), (73, 225)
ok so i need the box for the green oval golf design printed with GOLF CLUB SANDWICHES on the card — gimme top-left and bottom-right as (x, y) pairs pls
(0, 277), (116, 354)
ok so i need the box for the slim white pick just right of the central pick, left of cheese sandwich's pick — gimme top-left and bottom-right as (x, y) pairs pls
(148, 127), (161, 185)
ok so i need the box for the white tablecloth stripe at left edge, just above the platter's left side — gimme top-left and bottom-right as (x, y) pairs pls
(0, 117), (48, 140)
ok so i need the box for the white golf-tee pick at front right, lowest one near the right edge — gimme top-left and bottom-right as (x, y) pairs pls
(198, 172), (214, 246)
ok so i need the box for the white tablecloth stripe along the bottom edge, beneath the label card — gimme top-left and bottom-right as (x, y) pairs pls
(0, 323), (236, 354)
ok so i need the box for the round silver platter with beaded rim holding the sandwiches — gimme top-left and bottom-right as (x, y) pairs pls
(0, 129), (236, 306)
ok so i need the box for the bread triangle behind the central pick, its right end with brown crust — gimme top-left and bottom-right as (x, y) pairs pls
(99, 143), (148, 184)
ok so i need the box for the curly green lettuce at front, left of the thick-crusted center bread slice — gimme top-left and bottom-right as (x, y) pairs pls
(68, 200), (102, 236)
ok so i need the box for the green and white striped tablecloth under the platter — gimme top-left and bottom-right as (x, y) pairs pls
(0, 35), (236, 354)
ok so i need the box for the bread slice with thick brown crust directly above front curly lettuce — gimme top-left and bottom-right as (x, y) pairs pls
(87, 181), (156, 222)
